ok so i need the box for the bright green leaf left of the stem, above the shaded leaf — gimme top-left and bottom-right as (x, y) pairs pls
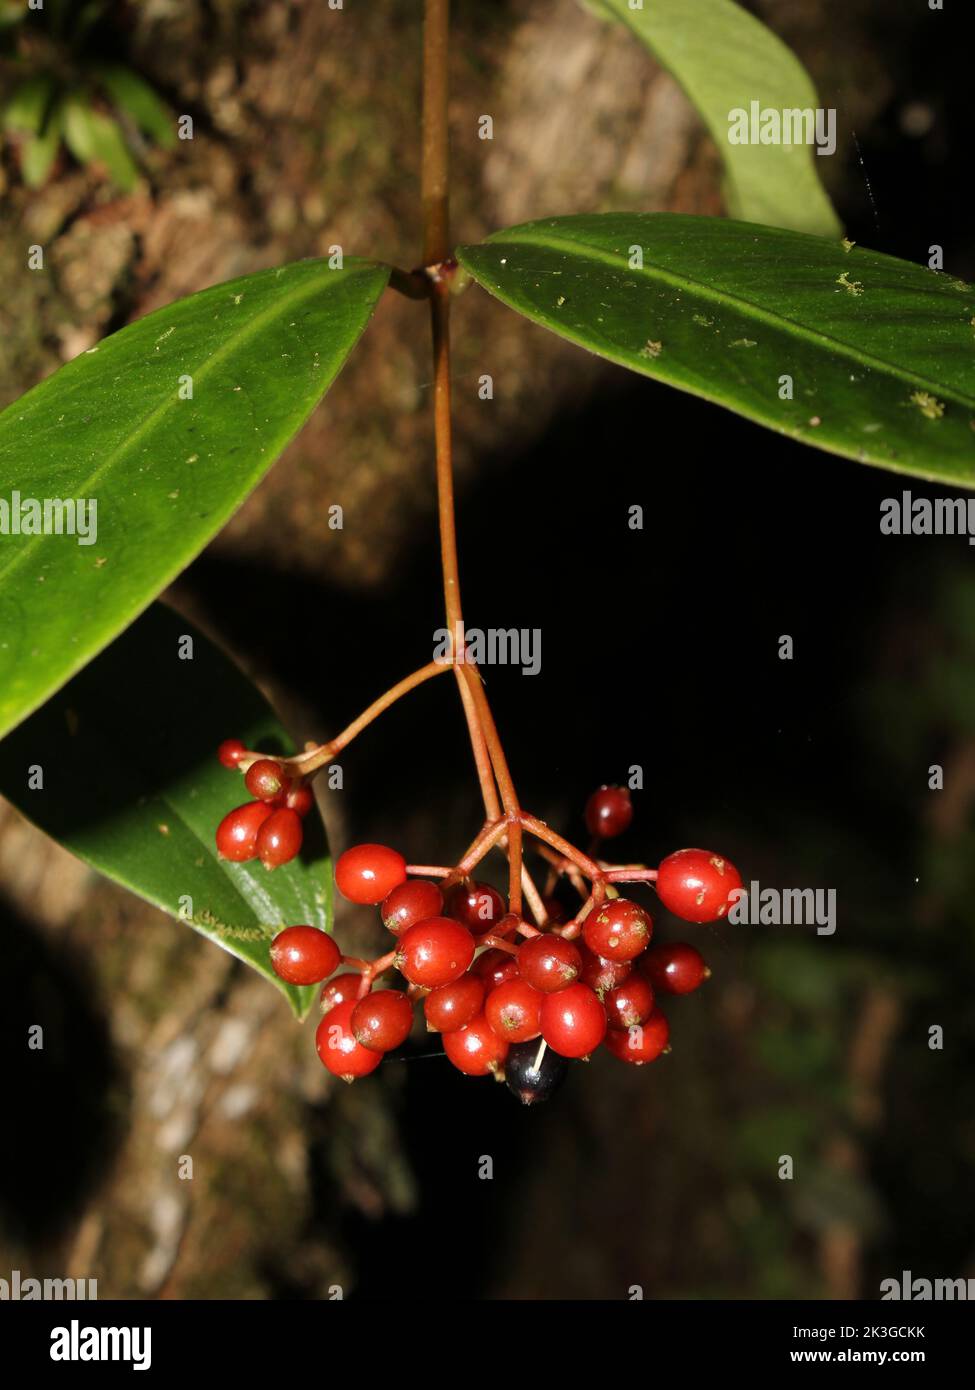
(0, 261), (389, 737)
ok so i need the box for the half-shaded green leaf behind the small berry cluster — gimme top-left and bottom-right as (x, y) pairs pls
(0, 603), (332, 1017)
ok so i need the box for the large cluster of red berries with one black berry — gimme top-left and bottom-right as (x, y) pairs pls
(253, 783), (741, 1102)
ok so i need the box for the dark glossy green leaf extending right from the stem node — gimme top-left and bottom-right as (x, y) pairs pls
(458, 213), (975, 487)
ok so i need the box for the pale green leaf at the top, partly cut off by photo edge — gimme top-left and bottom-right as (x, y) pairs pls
(578, 0), (841, 236)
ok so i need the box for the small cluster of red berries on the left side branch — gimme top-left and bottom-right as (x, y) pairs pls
(217, 738), (314, 869)
